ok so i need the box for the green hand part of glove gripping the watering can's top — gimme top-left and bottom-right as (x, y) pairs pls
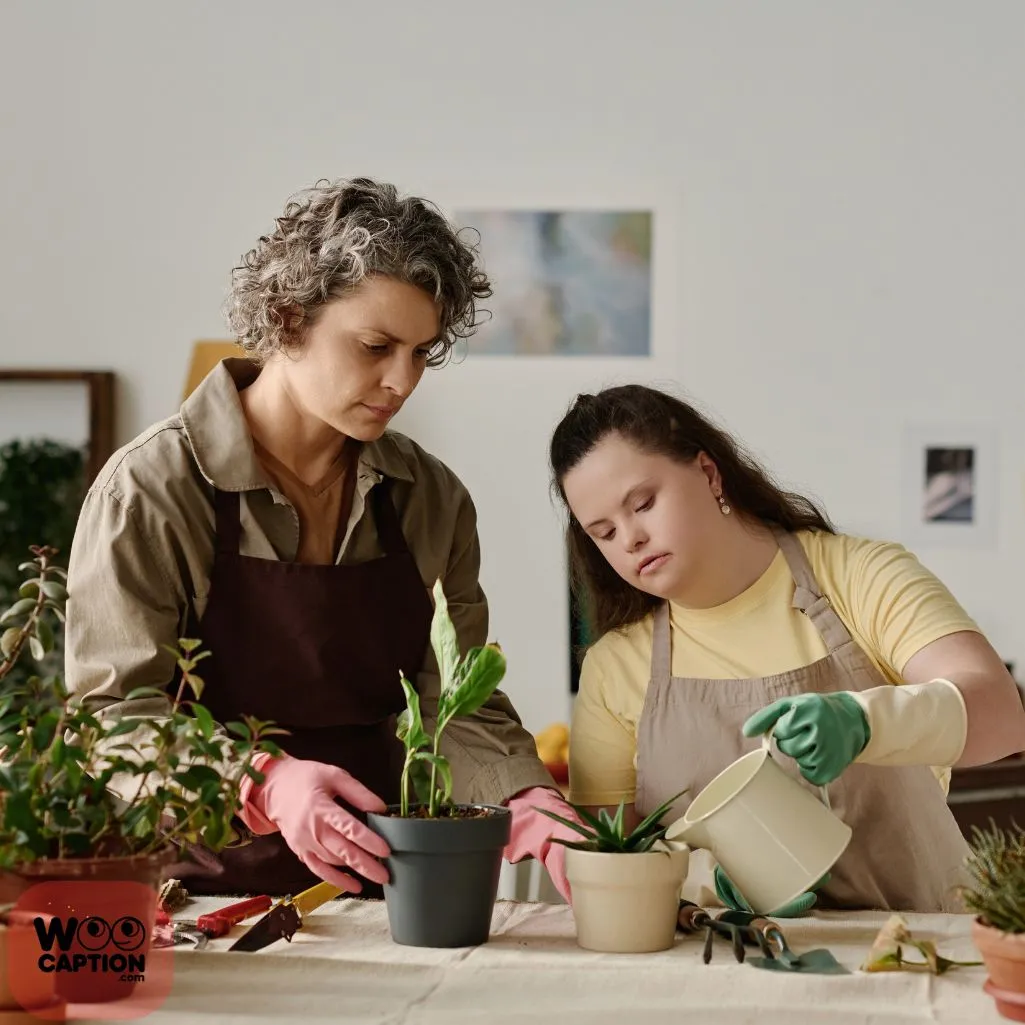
(744, 691), (871, 786)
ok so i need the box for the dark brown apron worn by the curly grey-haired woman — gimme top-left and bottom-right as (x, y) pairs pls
(173, 478), (433, 896)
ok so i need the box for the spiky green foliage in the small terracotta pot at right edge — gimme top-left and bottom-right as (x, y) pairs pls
(961, 820), (1025, 933)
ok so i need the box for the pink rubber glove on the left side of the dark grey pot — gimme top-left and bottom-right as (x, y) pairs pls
(239, 754), (391, 893)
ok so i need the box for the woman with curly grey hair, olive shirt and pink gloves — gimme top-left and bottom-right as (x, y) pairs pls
(67, 179), (572, 895)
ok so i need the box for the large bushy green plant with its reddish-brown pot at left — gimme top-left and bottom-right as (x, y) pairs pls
(0, 547), (281, 1002)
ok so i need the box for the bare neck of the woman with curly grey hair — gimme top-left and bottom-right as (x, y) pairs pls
(239, 363), (350, 486)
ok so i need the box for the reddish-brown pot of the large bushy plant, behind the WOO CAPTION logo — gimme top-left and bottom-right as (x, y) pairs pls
(0, 849), (176, 1006)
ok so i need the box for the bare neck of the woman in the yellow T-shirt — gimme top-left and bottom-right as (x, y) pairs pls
(671, 517), (779, 609)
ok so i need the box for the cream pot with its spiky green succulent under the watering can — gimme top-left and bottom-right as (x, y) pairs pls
(538, 790), (690, 953)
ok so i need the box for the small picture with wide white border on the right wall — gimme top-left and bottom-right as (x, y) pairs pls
(901, 423), (998, 547)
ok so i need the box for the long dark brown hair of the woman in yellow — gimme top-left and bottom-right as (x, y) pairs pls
(549, 384), (836, 640)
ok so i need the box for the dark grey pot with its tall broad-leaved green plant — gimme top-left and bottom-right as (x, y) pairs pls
(367, 580), (511, 947)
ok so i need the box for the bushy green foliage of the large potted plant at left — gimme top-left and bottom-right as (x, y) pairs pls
(0, 547), (284, 869)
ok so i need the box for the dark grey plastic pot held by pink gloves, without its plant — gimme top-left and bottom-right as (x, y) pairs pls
(367, 805), (513, 947)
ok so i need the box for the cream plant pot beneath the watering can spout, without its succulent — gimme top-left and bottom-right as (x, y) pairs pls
(566, 848), (690, 953)
